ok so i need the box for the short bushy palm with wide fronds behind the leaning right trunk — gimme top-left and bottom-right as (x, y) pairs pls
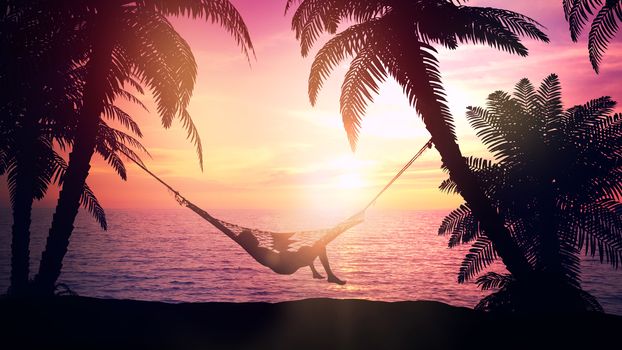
(439, 74), (622, 310)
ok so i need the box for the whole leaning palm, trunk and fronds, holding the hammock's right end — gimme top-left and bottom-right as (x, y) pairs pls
(286, 0), (548, 276)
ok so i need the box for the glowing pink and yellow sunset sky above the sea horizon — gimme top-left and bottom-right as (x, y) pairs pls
(0, 0), (622, 210)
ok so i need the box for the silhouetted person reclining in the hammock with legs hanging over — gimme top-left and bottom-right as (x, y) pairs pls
(236, 230), (346, 285)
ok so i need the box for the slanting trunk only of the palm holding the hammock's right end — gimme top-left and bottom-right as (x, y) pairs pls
(387, 34), (533, 279)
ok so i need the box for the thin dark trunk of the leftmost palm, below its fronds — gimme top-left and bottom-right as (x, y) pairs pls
(9, 174), (33, 295)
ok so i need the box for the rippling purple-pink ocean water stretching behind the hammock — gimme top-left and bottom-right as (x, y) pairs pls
(0, 208), (622, 315)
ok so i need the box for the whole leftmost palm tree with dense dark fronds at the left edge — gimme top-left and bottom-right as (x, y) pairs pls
(0, 3), (149, 295)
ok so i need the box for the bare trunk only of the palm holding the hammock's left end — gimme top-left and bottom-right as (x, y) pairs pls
(35, 8), (114, 294)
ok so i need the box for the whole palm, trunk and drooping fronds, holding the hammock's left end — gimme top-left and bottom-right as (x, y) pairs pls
(29, 0), (252, 294)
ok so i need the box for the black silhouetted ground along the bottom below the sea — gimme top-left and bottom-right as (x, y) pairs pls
(0, 297), (622, 350)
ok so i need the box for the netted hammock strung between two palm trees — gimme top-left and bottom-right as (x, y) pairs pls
(121, 139), (432, 272)
